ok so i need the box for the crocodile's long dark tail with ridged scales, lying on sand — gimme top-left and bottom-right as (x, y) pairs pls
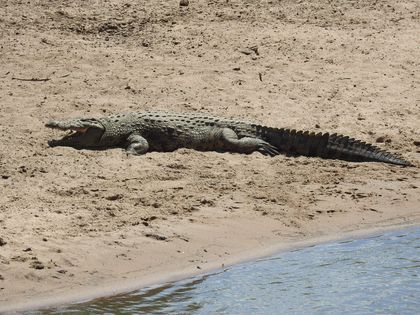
(256, 126), (412, 166)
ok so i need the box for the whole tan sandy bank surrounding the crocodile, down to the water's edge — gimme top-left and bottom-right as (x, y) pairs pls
(0, 0), (420, 311)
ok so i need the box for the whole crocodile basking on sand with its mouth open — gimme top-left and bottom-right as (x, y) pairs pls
(45, 111), (412, 166)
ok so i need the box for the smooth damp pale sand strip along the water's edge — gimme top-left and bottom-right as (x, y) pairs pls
(0, 210), (420, 313)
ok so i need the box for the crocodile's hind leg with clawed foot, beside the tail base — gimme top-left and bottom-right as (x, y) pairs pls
(220, 128), (280, 156)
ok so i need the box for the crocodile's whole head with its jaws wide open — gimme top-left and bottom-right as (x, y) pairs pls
(45, 119), (105, 149)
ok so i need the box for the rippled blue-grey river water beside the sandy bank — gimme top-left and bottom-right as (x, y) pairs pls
(32, 227), (420, 315)
